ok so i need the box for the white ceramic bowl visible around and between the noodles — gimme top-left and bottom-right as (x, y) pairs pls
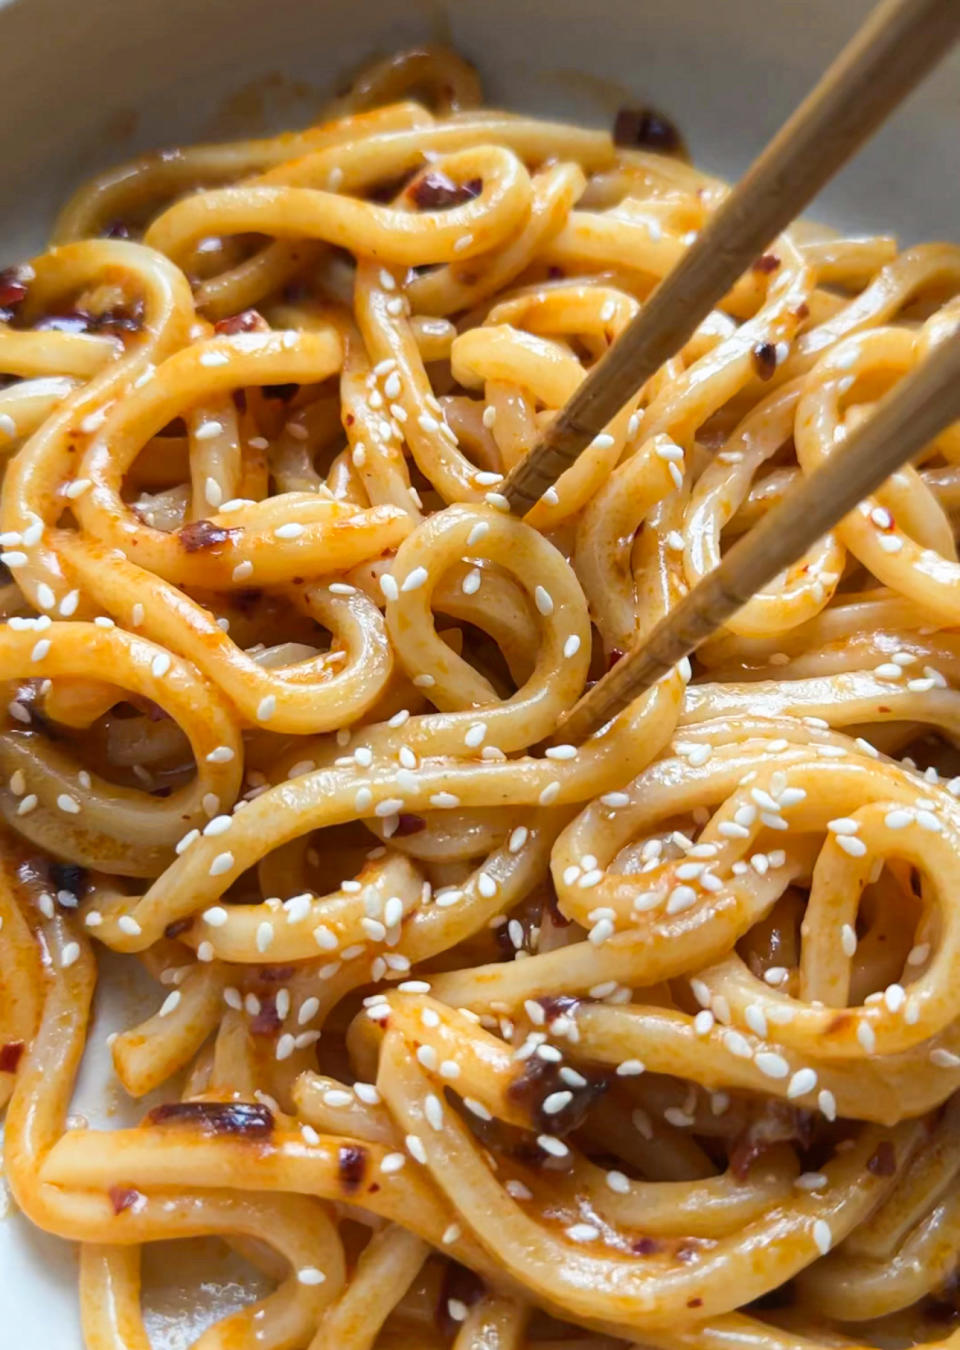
(0, 0), (960, 1350)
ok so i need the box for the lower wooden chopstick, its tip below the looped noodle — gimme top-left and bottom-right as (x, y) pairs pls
(556, 327), (960, 745)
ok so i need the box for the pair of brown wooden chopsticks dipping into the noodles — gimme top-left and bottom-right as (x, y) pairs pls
(501, 0), (960, 744)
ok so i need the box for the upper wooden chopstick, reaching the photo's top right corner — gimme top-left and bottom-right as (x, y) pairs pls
(500, 0), (960, 514)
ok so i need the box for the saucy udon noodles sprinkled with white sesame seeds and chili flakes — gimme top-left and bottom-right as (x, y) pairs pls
(0, 39), (960, 1350)
